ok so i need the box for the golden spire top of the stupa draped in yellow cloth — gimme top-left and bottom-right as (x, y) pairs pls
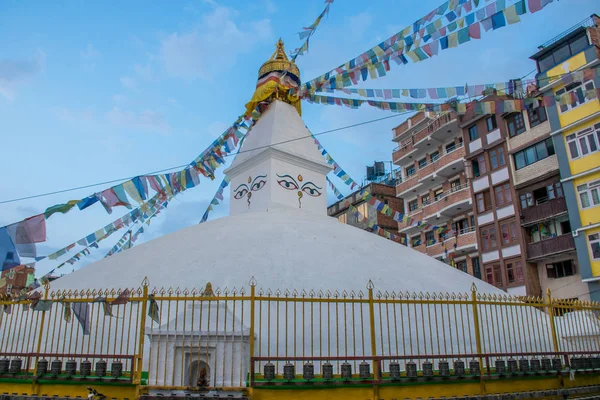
(246, 39), (302, 116)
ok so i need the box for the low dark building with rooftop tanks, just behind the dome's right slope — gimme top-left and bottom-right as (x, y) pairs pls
(327, 182), (403, 244)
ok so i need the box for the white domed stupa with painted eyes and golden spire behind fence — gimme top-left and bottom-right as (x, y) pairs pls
(35, 41), (548, 387)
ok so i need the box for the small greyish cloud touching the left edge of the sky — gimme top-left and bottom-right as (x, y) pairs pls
(0, 50), (46, 100)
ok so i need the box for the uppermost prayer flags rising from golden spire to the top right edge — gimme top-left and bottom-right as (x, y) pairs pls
(301, 0), (552, 93)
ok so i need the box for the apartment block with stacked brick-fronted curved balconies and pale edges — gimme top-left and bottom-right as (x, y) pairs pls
(392, 112), (481, 278)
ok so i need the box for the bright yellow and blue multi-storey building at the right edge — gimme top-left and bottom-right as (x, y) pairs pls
(528, 15), (600, 300)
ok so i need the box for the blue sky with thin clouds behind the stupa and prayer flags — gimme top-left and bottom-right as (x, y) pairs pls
(0, 0), (599, 274)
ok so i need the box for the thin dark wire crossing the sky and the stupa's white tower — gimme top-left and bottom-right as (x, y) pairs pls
(0, 111), (414, 204)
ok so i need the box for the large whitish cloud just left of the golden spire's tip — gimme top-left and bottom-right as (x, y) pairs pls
(160, 2), (272, 79)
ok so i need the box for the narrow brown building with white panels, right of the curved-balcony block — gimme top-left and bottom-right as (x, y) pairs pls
(460, 94), (541, 295)
